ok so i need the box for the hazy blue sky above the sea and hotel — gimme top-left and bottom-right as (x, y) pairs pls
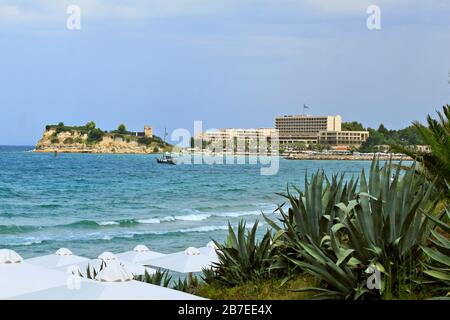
(0, 0), (450, 145)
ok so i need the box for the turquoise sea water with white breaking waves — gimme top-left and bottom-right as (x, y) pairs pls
(0, 147), (376, 257)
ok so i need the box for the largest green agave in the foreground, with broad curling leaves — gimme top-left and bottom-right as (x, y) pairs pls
(272, 159), (434, 299)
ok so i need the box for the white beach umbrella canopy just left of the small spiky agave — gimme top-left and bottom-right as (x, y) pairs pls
(144, 247), (213, 273)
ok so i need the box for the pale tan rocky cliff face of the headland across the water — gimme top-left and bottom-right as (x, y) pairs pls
(34, 128), (168, 154)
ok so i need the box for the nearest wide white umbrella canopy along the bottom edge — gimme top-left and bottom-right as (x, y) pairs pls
(9, 279), (205, 300)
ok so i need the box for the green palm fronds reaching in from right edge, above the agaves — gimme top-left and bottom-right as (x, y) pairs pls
(391, 105), (450, 198)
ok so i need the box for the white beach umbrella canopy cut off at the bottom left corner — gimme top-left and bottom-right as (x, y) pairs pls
(0, 262), (68, 299)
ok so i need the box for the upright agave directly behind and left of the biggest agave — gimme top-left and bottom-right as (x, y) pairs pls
(264, 172), (357, 274)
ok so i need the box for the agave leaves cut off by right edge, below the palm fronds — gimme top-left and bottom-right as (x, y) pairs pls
(422, 208), (450, 299)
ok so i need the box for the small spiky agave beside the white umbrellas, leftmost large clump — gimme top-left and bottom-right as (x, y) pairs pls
(209, 221), (272, 286)
